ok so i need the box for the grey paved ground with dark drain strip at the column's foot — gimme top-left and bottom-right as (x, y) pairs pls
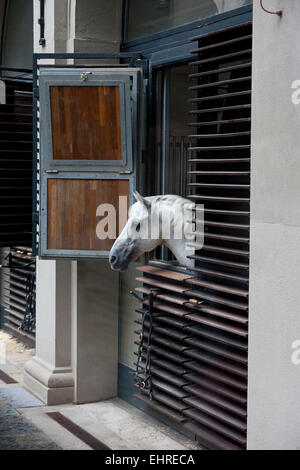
(0, 330), (199, 451)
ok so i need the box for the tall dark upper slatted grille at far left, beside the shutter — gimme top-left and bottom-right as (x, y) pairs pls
(0, 69), (32, 247)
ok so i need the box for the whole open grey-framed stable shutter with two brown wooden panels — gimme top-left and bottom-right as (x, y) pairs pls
(39, 68), (141, 258)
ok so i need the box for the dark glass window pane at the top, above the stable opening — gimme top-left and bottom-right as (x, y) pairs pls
(127, 0), (252, 41)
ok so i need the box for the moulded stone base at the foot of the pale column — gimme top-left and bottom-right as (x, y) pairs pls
(24, 357), (74, 405)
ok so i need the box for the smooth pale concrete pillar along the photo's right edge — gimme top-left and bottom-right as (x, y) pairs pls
(248, 0), (300, 450)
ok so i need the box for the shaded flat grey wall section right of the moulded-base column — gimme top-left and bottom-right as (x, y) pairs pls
(72, 260), (119, 403)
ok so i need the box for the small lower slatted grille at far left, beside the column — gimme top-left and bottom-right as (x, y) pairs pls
(3, 247), (36, 344)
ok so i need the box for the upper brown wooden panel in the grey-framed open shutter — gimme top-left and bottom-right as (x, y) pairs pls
(50, 86), (122, 160)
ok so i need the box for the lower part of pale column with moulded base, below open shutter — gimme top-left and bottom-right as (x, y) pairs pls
(24, 260), (74, 405)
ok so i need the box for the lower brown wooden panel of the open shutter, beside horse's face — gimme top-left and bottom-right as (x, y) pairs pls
(47, 178), (129, 250)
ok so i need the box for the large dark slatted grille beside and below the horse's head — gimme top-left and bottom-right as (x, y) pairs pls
(135, 23), (252, 449)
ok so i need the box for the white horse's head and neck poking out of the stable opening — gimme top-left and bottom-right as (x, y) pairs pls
(109, 192), (195, 271)
